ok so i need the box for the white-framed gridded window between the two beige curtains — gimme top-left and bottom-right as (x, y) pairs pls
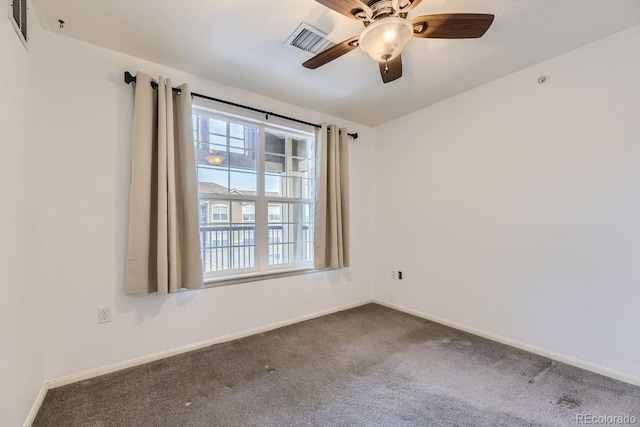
(193, 107), (315, 280)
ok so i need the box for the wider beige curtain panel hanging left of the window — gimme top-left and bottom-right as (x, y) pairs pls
(126, 73), (203, 295)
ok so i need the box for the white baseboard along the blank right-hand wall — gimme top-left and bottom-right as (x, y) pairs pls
(373, 299), (640, 386)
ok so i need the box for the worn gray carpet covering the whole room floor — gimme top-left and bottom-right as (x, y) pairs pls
(34, 304), (640, 427)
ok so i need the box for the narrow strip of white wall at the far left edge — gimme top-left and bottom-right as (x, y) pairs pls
(0, 1), (44, 426)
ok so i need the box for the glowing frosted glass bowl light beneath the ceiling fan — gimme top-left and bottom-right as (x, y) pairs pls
(360, 17), (413, 62)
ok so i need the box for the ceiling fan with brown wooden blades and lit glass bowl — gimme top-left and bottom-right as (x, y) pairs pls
(302, 0), (494, 83)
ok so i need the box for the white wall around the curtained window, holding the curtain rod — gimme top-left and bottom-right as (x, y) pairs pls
(38, 33), (373, 380)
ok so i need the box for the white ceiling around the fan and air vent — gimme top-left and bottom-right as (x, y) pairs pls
(32, 0), (640, 126)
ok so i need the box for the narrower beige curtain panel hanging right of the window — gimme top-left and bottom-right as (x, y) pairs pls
(314, 124), (349, 269)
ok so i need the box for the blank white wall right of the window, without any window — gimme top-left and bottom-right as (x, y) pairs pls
(374, 27), (640, 380)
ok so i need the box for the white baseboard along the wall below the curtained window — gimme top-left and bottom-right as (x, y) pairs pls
(48, 299), (373, 390)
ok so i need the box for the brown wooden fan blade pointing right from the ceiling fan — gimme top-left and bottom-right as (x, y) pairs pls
(411, 13), (494, 39)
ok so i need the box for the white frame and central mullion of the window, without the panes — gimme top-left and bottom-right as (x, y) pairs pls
(193, 105), (315, 284)
